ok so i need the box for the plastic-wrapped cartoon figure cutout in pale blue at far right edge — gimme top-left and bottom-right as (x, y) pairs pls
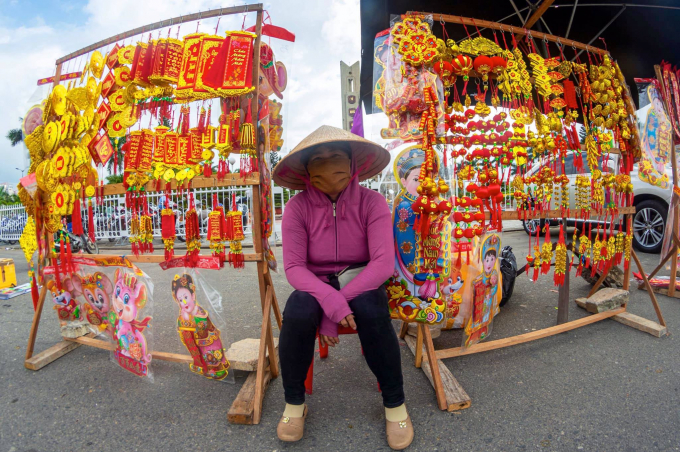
(636, 79), (673, 189)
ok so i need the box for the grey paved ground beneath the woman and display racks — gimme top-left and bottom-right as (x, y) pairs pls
(0, 232), (680, 452)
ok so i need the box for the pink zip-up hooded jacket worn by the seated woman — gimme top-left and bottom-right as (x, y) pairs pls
(282, 154), (394, 337)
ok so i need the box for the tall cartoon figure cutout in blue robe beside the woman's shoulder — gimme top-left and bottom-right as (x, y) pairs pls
(387, 146), (449, 324)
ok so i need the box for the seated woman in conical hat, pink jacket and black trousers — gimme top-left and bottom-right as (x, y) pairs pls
(273, 126), (413, 450)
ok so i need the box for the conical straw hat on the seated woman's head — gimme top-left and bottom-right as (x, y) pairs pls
(273, 126), (390, 190)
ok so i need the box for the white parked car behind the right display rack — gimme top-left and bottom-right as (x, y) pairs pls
(523, 152), (672, 253)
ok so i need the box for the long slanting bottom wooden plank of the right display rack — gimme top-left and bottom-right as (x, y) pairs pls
(437, 308), (626, 359)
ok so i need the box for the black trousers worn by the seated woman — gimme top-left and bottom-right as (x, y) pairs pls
(279, 287), (404, 408)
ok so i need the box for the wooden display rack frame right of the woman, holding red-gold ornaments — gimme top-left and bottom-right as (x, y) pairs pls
(399, 12), (668, 411)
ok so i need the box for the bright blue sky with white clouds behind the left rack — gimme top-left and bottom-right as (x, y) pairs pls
(0, 0), (377, 183)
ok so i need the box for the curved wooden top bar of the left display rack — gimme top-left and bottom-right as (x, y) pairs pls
(57, 3), (262, 64)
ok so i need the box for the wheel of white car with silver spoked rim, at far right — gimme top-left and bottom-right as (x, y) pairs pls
(633, 199), (668, 253)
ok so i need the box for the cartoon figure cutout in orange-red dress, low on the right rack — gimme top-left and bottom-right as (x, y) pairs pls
(463, 233), (503, 347)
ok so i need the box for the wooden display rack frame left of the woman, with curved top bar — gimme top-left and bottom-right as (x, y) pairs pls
(24, 4), (281, 424)
